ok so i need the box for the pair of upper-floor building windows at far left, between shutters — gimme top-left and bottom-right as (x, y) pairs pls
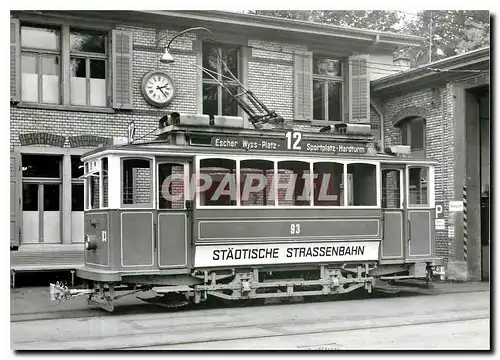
(21, 24), (109, 107)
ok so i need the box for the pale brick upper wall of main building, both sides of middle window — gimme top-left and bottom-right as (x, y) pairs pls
(10, 20), (372, 150)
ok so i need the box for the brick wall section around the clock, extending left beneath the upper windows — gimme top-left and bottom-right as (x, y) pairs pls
(10, 25), (197, 150)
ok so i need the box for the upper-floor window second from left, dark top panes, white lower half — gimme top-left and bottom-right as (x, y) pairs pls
(69, 29), (107, 107)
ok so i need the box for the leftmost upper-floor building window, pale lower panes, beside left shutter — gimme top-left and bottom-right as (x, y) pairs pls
(21, 25), (61, 104)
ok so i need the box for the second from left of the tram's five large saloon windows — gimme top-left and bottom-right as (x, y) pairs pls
(240, 160), (274, 206)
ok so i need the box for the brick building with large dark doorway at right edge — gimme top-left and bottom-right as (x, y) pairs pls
(371, 47), (491, 280)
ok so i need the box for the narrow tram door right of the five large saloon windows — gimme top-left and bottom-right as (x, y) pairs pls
(381, 164), (406, 263)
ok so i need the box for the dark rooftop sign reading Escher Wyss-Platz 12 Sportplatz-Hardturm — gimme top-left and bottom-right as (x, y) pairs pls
(212, 131), (367, 154)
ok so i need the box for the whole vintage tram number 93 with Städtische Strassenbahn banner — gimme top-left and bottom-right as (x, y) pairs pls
(51, 114), (442, 311)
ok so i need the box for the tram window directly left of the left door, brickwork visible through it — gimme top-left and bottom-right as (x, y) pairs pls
(122, 159), (153, 207)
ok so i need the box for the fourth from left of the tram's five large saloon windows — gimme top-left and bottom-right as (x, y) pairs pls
(313, 162), (344, 206)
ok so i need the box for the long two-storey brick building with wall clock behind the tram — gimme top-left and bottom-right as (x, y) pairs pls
(10, 11), (422, 276)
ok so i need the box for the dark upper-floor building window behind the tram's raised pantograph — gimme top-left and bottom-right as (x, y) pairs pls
(203, 43), (240, 116)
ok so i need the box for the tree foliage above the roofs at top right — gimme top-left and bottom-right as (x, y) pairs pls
(250, 10), (490, 66)
